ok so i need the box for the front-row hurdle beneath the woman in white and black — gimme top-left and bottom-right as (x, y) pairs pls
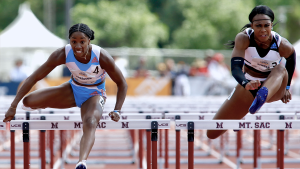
(175, 120), (300, 169)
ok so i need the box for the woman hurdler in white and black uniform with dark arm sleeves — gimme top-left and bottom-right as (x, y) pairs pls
(207, 5), (296, 139)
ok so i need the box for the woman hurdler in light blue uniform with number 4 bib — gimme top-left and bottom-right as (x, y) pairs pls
(3, 24), (127, 169)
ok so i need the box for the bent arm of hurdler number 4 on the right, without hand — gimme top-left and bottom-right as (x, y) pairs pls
(99, 49), (127, 110)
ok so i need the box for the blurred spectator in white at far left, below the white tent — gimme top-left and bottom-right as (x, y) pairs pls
(10, 59), (30, 82)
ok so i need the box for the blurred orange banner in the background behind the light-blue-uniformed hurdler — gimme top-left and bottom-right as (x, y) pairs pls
(45, 78), (172, 96)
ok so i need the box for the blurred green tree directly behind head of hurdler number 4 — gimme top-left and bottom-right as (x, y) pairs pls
(72, 0), (168, 47)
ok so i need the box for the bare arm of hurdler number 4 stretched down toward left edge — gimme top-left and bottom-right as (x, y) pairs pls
(3, 47), (66, 122)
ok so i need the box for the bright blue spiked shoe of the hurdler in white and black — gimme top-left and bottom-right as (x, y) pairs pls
(249, 86), (268, 114)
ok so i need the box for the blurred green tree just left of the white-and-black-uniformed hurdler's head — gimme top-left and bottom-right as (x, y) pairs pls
(170, 0), (254, 49)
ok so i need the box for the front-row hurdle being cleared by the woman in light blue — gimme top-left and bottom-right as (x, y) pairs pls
(0, 119), (170, 169)
